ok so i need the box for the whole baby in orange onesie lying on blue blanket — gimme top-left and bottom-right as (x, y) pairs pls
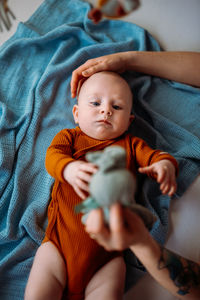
(25, 72), (178, 300)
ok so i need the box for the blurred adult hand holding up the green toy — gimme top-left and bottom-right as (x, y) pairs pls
(86, 204), (149, 251)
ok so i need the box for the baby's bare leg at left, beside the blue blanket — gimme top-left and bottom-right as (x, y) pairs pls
(24, 242), (66, 300)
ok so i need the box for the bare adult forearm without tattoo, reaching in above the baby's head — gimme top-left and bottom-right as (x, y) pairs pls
(126, 51), (200, 87)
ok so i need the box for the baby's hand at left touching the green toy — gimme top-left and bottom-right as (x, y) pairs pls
(63, 160), (97, 200)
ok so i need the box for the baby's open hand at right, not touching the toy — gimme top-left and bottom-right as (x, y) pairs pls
(138, 159), (176, 196)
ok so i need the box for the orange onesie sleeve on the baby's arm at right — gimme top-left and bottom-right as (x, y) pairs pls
(132, 138), (178, 176)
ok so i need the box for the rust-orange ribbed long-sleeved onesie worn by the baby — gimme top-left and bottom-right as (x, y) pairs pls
(43, 127), (177, 300)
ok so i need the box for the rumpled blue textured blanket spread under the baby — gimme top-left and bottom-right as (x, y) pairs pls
(0, 0), (200, 300)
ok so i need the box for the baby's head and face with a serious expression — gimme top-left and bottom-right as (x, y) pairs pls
(73, 72), (133, 140)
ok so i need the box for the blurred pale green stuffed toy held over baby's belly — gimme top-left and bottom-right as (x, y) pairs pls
(76, 146), (156, 229)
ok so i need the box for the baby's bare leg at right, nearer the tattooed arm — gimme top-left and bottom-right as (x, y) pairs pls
(85, 257), (126, 300)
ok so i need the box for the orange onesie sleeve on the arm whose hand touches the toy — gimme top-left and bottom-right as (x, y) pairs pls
(45, 129), (74, 182)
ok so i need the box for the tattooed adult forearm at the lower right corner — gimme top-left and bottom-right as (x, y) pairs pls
(130, 237), (200, 300)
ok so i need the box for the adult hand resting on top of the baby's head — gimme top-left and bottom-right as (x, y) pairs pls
(71, 52), (128, 98)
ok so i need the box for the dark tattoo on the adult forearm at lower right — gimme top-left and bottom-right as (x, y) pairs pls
(158, 248), (200, 295)
